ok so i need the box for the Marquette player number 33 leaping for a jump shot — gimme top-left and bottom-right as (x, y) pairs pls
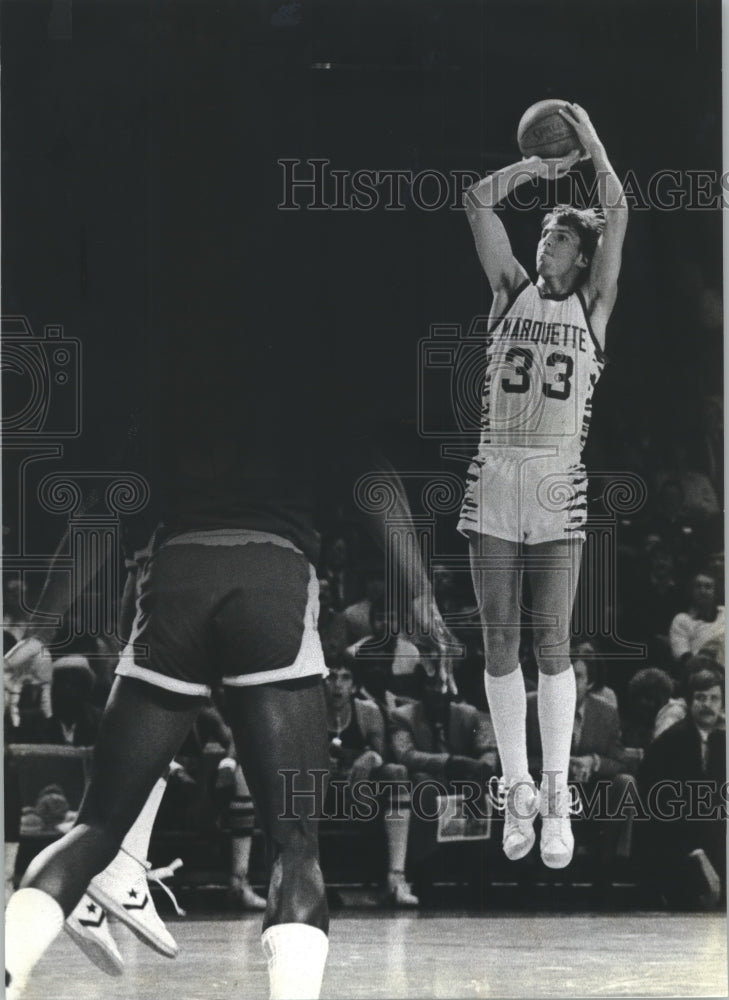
(458, 104), (628, 868)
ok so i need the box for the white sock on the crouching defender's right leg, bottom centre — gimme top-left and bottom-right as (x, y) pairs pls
(261, 924), (329, 1000)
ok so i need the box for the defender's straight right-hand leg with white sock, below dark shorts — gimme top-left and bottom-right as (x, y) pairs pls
(227, 676), (329, 998)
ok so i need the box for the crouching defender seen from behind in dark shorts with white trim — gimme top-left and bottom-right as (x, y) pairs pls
(5, 414), (448, 1000)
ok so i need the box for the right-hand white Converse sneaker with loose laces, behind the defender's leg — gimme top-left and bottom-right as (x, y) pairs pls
(86, 855), (179, 958)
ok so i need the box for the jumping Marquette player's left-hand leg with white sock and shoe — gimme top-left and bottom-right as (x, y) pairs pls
(469, 534), (538, 861)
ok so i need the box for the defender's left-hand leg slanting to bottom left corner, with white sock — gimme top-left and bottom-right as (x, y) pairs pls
(5, 678), (201, 997)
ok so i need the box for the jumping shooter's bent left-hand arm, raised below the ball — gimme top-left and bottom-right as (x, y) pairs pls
(463, 153), (579, 297)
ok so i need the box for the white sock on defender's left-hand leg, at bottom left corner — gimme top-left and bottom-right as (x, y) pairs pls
(5, 889), (65, 988)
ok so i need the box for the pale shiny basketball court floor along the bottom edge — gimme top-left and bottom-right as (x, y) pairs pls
(19, 911), (727, 1000)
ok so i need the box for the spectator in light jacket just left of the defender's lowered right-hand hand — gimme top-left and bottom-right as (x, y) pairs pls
(345, 598), (420, 711)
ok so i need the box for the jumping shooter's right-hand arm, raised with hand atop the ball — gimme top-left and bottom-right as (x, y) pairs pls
(560, 104), (628, 332)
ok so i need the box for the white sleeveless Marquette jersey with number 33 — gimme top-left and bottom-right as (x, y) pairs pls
(480, 281), (605, 461)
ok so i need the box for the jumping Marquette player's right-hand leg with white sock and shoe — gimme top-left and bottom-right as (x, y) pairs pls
(528, 539), (582, 868)
